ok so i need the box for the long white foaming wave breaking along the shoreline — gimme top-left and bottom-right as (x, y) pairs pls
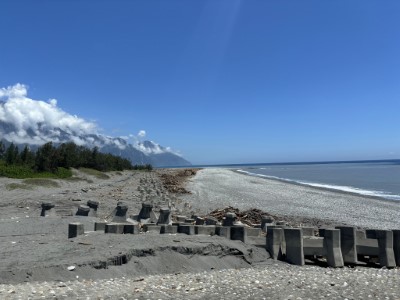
(236, 169), (400, 201)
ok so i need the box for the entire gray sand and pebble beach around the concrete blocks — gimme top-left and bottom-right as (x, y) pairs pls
(0, 169), (400, 299)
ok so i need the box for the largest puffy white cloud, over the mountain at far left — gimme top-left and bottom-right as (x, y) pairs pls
(0, 83), (97, 145)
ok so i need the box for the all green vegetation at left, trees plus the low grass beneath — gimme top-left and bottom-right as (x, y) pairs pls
(0, 142), (141, 179)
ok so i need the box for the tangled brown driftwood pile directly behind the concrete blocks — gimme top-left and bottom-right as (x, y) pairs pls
(207, 206), (276, 226)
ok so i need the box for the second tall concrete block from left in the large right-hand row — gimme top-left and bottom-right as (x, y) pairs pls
(284, 228), (304, 266)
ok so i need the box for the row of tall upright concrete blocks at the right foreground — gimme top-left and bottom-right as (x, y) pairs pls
(266, 226), (400, 268)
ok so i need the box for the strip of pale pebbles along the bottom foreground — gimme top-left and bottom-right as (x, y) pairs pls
(0, 264), (400, 300)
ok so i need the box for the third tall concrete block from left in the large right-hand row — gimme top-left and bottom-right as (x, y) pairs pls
(324, 229), (344, 268)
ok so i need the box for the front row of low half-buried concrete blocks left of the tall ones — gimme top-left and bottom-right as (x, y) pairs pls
(68, 222), (261, 243)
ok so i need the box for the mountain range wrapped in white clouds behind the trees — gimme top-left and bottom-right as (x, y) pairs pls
(0, 83), (188, 166)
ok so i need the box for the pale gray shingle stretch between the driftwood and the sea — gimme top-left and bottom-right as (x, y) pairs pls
(184, 169), (400, 229)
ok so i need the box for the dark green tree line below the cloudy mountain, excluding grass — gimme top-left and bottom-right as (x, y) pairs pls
(0, 141), (147, 173)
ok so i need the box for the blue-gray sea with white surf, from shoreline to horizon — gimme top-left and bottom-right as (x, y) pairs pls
(234, 160), (400, 200)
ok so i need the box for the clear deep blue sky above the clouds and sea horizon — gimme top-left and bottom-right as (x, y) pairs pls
(0, 0), (400, 164)
